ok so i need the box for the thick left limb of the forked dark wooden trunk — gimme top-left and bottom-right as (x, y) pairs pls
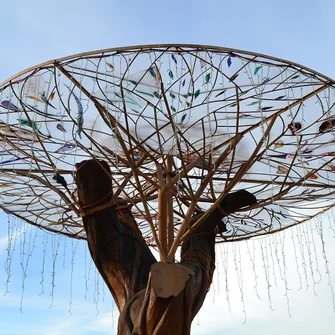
(76, 160), (156, 311)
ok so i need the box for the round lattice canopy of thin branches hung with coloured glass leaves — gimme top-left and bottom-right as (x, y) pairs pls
(0, 45), (335, 258)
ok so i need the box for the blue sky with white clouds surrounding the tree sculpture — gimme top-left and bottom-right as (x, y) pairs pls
(0, 0), (335, 335)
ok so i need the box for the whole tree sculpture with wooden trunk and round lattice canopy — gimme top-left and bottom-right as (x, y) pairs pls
(0, 45), (335, 335)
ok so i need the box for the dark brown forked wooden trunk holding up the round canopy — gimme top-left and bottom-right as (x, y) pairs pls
(76, 160), (256, 335)
